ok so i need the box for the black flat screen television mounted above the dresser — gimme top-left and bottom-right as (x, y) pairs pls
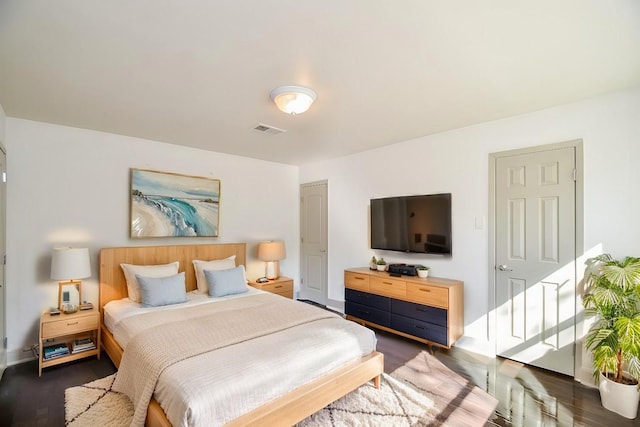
(371, 193), (451, 255)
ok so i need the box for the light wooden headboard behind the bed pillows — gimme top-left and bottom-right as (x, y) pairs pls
(99, 243), (247, 313)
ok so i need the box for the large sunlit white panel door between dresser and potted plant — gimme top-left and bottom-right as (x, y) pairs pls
(495, 147), (576, 376)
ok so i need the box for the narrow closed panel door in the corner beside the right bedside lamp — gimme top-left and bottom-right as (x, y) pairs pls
(300, 182), (327, 305)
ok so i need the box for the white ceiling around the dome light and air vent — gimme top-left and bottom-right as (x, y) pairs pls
(0, 0), (640, 165)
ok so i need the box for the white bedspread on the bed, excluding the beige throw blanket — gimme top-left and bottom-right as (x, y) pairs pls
(105, 295), (375, 426)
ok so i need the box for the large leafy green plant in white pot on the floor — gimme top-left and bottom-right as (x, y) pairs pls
(583, 254), (640, 419)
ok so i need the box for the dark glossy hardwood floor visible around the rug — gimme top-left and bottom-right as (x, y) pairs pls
(0, 331), (640, 427)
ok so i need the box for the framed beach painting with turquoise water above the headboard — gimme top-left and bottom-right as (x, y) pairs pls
(131, 169), (220, 238)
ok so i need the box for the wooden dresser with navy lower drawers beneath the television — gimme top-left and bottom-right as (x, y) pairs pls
(344, 268), (464, 348)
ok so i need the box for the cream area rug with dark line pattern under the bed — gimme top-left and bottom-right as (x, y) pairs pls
(65, 352), (497, 427)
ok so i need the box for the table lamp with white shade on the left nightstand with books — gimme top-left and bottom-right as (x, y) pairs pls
(51, 248), (91, 311)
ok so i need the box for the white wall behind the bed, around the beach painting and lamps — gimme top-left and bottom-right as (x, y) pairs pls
(6, 118), (299, 363)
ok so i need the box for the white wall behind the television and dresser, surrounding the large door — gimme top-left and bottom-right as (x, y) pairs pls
(300, 89), (640, 382)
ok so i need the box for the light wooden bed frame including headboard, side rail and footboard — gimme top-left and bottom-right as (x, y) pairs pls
(99, 243), (384, 427)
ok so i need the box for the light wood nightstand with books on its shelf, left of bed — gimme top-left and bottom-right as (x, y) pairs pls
(38, 308), (100, 376)
